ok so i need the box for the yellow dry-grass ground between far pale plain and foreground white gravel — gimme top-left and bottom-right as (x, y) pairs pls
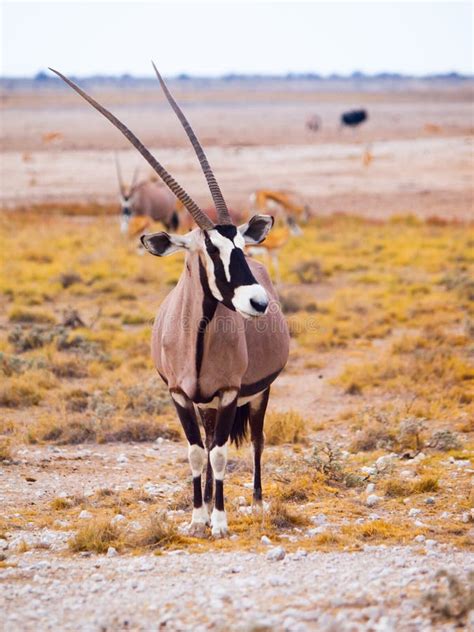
(0, 214), (474, 563)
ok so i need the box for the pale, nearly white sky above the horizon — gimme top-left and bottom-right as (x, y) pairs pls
(0, 0), (473, 76)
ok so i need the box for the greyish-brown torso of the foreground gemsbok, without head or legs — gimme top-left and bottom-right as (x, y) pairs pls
(152, 246), (289, 403)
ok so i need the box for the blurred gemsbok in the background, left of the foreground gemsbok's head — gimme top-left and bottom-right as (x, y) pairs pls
(115, 155), (179, 236)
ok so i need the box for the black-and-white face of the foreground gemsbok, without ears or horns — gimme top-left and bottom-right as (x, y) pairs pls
(204, 225), (269, 318)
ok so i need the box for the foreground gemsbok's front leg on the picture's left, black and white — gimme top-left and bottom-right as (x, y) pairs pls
(171, 391), (209, 537)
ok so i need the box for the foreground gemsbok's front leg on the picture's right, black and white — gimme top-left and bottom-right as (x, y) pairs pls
(209, 390), (238, 538)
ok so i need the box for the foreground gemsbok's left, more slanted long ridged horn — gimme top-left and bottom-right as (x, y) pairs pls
(50, 68), (214, 230)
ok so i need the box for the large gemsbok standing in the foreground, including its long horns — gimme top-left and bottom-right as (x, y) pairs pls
(53, 67), (289, 537)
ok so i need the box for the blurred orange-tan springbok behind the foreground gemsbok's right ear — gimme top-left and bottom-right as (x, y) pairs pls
(249, 189), (309, 283)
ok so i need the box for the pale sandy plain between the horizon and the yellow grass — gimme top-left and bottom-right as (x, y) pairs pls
(0, 84), (474, 218)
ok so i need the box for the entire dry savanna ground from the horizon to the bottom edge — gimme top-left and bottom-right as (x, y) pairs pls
(0, 78), (474, 632)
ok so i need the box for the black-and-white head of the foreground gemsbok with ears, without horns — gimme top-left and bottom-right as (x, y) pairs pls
(141, 215), (273, 318)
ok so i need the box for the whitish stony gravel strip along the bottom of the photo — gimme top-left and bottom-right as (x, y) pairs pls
(0, 547), (474, 632)
